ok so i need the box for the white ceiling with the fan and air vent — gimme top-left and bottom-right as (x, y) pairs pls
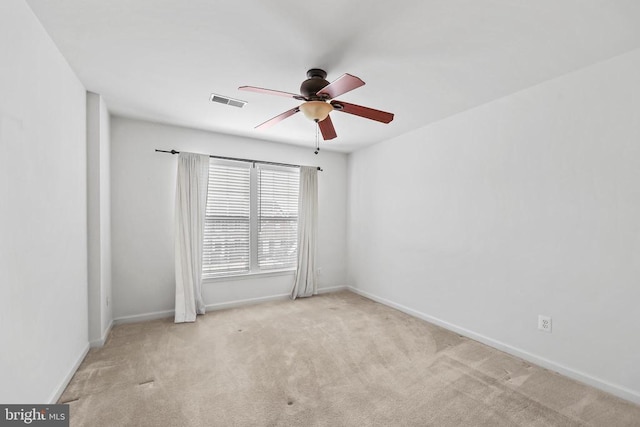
(27, 0), (640, 152)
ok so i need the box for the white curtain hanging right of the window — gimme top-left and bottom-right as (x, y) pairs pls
(291, 166), (318, 299)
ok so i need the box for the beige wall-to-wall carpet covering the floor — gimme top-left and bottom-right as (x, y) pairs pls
(60, 292), (640, 427)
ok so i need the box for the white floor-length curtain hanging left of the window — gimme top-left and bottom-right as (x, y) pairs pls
(175, 153), (209, 323)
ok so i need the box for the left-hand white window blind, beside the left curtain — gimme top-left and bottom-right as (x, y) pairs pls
(202, 162), (251, 277)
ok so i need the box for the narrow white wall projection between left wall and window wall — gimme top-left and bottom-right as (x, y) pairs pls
(87, 92), (113, 347)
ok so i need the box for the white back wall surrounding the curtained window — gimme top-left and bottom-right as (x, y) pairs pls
(111, 117), (347, 319)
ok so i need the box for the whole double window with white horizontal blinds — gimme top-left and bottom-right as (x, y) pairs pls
(202, 160), (300, 278)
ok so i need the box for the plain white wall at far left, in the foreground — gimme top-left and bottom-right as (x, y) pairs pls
(0, 0), (88, 403)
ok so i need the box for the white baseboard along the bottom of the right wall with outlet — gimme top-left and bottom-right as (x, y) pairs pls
(348, 286), (640, 404)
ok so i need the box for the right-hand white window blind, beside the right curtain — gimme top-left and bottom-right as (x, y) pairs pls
(258, 167), (300, 270)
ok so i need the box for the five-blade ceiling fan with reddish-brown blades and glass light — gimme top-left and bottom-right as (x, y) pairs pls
(238, 68), (393, 140)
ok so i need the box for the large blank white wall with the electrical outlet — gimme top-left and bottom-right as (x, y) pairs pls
(348, 51), (640, 402)
